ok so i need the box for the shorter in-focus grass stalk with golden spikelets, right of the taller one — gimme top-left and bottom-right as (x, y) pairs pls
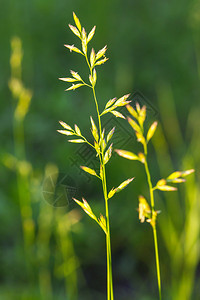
(115, 103), (194, 300)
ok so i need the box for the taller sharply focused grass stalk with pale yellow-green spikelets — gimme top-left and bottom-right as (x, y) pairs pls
(58, 13), (133, 300)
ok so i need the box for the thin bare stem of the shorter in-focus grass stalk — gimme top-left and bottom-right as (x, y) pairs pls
(144, 143), (162, 300)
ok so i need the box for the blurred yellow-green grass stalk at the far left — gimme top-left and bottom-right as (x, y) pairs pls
(8, 37), (35, 273)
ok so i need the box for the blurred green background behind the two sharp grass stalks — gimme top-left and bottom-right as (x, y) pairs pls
(0, 0), (200, 300)
